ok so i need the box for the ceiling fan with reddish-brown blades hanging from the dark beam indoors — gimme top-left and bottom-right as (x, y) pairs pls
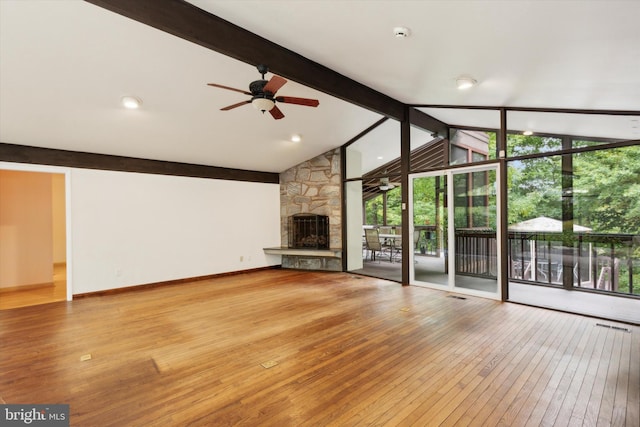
(207, 65), (320, 120)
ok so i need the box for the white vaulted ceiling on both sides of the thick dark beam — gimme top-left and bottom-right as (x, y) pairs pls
(0, 0), (640, 172)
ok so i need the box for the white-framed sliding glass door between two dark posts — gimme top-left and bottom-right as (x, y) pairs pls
(409, 165), (500, 299)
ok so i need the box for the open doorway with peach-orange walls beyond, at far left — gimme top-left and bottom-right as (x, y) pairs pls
(0, 169), (70, 310)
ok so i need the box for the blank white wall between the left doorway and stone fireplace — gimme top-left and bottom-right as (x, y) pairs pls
(71, 169), (280, 294)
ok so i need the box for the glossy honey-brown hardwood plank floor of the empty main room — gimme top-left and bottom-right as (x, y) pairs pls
(0, 270), (640, 427)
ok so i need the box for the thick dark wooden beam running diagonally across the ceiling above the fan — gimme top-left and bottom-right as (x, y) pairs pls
(85, 0), (405, 121)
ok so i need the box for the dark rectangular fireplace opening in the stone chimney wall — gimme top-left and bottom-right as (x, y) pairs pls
(289, 214), (329, 249)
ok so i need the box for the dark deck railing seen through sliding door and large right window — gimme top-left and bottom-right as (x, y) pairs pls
(455, 229), (640, 295)
